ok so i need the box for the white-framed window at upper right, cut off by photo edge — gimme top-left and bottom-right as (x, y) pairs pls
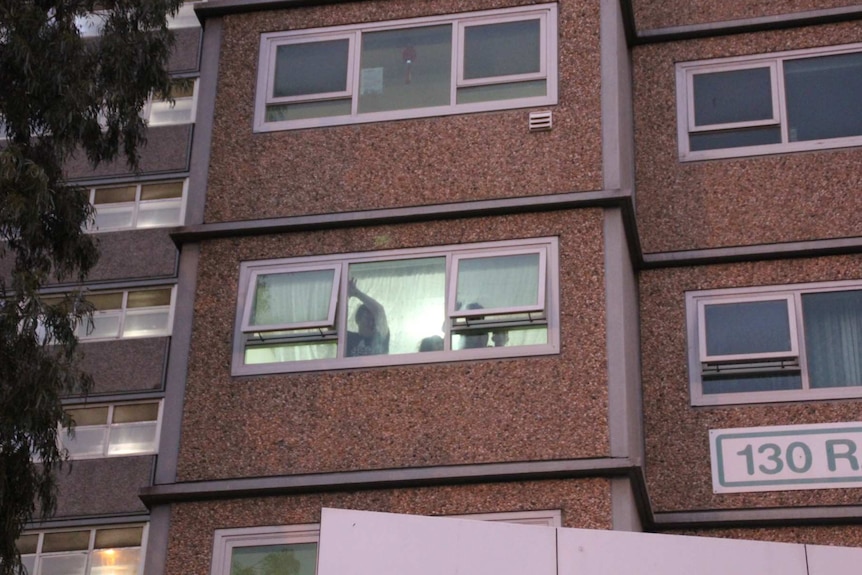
(677, 44), (862, 160)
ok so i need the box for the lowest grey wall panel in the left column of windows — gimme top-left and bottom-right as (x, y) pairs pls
(55, 455), (156, 519)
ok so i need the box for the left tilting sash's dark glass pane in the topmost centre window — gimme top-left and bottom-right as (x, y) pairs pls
(272, 38), (350, 98)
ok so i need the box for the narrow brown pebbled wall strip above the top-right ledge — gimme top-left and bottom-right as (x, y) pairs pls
(632, 0), (853, 31)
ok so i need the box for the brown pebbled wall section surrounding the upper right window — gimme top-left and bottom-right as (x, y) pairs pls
(633, 23), (862, 253)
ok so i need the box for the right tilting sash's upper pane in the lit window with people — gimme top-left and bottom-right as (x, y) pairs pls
(456, 254), (544, 310)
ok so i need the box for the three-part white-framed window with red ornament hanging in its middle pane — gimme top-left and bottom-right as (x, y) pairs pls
(255, 4), (557, 131)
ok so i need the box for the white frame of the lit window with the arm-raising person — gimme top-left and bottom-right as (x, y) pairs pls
(231, 237), (560, 375)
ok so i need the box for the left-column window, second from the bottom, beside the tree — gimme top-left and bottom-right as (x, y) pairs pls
(60, 401), (161, 459)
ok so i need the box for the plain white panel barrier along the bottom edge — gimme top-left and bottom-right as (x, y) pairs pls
(317, 509), (862, 575)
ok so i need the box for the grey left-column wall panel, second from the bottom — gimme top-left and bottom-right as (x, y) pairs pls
(78, 337), (170, 395)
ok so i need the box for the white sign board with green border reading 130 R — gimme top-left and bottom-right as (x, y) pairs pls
(709, 422), (862, 493)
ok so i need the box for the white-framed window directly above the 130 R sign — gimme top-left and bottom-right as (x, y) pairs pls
(686, 282), (862, 405)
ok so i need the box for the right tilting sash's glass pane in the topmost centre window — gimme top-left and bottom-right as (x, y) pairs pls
(464, 19), (542, 80)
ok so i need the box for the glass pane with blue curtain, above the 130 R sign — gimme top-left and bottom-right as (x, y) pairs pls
(802, 291), (862, 387)
